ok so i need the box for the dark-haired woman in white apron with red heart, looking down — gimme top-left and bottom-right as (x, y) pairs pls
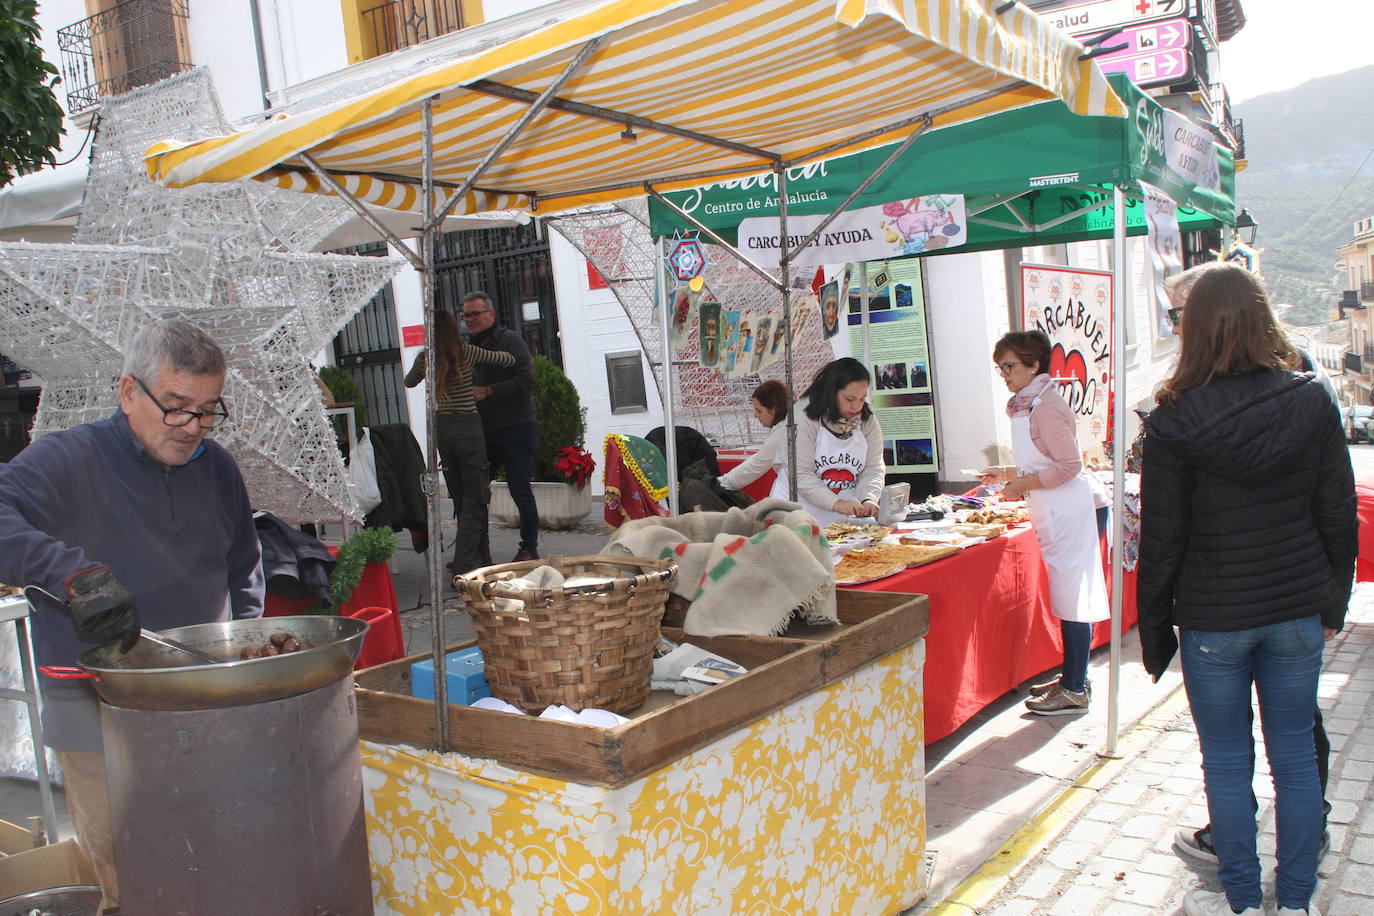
(769, 357), (886, 527)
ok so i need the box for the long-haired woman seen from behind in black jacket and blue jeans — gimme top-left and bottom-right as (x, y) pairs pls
(1136, 262), (1356, 916)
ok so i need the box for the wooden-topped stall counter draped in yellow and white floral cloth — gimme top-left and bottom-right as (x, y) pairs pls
(357, 592), (929, 916)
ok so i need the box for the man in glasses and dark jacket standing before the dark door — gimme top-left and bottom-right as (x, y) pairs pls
(463, 290), (539, 563)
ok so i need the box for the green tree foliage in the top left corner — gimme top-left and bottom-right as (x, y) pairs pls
(0, 0), (65, 187)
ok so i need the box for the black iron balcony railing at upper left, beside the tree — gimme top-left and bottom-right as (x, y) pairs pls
(58, 0), (191, 114)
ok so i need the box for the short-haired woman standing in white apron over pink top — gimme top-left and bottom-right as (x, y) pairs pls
(992, 331), (1112, 715)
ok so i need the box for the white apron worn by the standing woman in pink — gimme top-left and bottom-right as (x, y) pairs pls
(1011, 398), (1112, 623)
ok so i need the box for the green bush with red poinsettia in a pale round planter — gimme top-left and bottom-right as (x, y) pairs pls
(489, 356), (596, 531)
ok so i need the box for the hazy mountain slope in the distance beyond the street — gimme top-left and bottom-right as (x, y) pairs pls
(1234, 63), (1374, 324)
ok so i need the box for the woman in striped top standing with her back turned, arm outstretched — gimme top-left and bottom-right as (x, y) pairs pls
(405, 309), (515, 573)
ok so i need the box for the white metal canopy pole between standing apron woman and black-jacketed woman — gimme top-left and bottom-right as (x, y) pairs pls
(1101, 184), (1128, 757)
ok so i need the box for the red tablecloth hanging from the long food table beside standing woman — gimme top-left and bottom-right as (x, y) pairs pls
(853, 526), (1136, 743)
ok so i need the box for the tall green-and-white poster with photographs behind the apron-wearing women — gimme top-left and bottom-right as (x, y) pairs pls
(846, 258), (940, 474)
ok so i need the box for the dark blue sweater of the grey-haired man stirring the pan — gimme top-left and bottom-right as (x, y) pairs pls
(0, 411), (262, 750)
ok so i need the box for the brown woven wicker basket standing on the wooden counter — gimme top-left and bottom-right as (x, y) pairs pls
(453, 556), (677, 713)
